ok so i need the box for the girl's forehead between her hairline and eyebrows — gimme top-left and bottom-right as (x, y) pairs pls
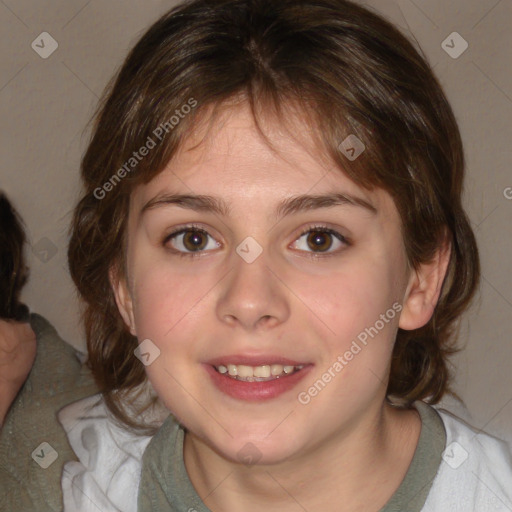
(131, 103), (396, 223)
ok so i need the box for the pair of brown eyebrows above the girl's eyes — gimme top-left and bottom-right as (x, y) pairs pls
(140, 193), (377, 218)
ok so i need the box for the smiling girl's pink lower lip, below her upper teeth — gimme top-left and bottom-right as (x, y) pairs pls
(205, 364), (313, 402)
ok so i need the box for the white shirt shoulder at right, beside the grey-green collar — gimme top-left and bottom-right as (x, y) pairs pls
(423, 409), (512, 512)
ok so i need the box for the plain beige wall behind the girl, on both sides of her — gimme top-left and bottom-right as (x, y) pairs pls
(0, 0), (512, 443)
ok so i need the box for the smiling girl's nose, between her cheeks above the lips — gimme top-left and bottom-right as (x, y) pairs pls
(216, 251), (290, 331)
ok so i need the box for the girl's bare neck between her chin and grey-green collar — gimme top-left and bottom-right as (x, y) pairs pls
(184, 403), (421, 512)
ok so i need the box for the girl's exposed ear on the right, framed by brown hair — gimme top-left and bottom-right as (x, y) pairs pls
(398, 231), (451, 330)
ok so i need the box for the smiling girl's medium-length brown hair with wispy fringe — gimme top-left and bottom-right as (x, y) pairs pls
(68, 0), (480, 434)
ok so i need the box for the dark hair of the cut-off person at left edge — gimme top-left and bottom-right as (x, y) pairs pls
(0, 192), (28, 320)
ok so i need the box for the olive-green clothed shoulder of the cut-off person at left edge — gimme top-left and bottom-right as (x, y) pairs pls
(0, 313), (97, 512)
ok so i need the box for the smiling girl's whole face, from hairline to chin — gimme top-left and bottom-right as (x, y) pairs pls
(114, 102), (428, 463)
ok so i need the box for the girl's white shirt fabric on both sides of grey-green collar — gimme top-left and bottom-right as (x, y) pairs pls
(59, 395), (512, 512)
